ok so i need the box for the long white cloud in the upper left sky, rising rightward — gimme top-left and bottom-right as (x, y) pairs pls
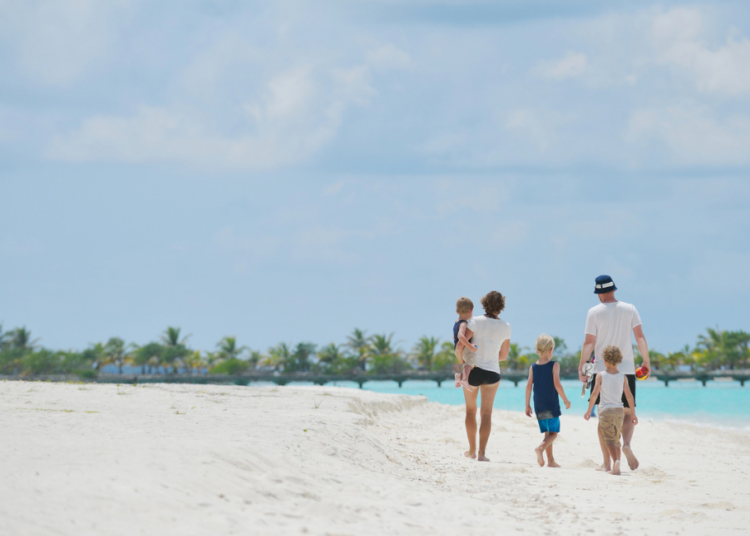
(48, 67), (377, 169)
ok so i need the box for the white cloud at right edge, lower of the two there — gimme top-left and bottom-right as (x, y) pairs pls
(625, 102), (750, 166)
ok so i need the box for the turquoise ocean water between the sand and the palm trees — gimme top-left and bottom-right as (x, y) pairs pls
(282, 380), (750, 430)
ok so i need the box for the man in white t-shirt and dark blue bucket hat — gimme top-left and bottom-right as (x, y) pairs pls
(578, 275), (651, 471)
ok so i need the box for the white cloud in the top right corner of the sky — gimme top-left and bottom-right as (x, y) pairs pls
(653, 9), (750, 96)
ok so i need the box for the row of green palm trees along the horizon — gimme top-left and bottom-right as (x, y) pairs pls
(0, 325), (750, 378)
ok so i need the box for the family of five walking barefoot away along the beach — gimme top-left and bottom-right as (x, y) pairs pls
(453, 275), (651, 475)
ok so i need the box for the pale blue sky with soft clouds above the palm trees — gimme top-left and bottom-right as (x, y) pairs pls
(0, 0), (750, 352)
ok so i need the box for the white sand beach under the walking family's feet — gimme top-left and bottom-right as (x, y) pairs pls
(0, 381), (750, 536)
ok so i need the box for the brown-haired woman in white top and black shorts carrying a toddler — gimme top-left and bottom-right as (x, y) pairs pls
(464, 290), (510, 462)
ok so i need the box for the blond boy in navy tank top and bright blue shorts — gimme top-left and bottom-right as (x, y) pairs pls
(526, 334), (570, 467)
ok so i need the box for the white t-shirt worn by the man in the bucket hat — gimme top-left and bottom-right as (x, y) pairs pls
(586, 302), (641, 374)
